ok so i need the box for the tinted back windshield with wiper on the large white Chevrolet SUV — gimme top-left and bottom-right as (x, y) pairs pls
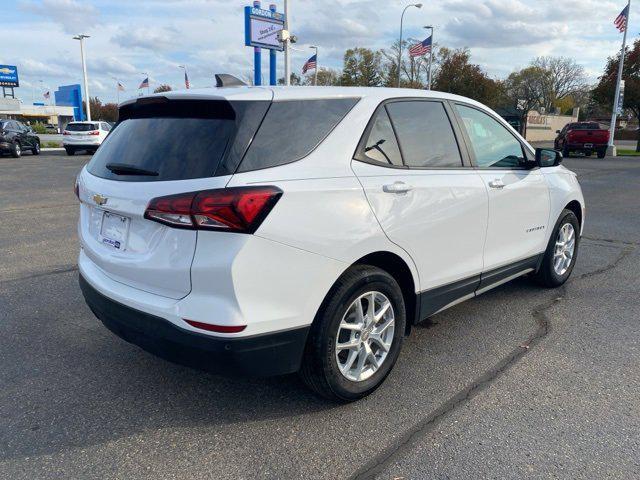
(87, 97), (269, 182)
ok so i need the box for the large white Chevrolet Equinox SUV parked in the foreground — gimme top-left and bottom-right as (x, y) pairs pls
(76, 87), (584, 401)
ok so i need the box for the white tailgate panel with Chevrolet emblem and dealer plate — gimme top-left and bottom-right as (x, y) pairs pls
(78, 169), (230, 299)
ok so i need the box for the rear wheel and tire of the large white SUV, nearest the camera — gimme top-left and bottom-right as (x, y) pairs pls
(300, 265), (406, 402)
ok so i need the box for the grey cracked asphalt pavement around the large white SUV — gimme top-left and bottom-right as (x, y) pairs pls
(0, 155), (640, 479)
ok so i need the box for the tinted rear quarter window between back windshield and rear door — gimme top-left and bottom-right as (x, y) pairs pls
(238, 98), (359, 172)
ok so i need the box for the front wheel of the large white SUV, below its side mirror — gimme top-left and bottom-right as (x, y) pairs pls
(535, 209), (580, 288)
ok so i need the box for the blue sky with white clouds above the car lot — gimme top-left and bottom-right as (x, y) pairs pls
(0, 0), (640, 102)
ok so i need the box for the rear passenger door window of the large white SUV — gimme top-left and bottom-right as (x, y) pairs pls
(387, 100), (462, 168)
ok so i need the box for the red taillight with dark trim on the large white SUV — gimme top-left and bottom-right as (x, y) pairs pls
(144, 186), (282, 233)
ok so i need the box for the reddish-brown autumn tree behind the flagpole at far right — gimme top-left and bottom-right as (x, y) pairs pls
(592, 40), (640, 152)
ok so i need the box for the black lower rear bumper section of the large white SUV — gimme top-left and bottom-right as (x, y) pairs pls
(80, 275), (310, 376)
